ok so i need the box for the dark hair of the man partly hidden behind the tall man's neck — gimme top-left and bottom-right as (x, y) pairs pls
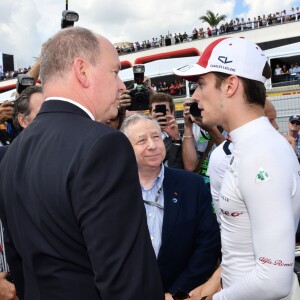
(13, 85), (43, 132)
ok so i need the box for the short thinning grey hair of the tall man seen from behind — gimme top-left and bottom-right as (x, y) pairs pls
(40, 27), (100, 84)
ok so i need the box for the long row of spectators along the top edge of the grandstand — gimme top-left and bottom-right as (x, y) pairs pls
(116, 7), (300, 55)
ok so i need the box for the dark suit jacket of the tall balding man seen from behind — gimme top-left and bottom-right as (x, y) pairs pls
(0, 100), (164, 300)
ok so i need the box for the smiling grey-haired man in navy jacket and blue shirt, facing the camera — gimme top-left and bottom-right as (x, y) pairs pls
(121, 114), (220, 300)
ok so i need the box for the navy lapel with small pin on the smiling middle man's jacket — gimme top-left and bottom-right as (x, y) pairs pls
(158, 167), (182, 257)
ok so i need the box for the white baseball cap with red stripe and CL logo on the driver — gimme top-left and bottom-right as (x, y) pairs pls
(173, 37), (267, 83)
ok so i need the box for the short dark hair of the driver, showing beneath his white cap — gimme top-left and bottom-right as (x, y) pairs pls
(214, 62), (272, 107)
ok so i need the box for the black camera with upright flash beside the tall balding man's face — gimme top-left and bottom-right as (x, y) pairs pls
(127, 65), (149, 110)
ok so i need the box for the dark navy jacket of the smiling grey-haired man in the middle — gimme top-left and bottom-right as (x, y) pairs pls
(157, 168), (220, 293)
